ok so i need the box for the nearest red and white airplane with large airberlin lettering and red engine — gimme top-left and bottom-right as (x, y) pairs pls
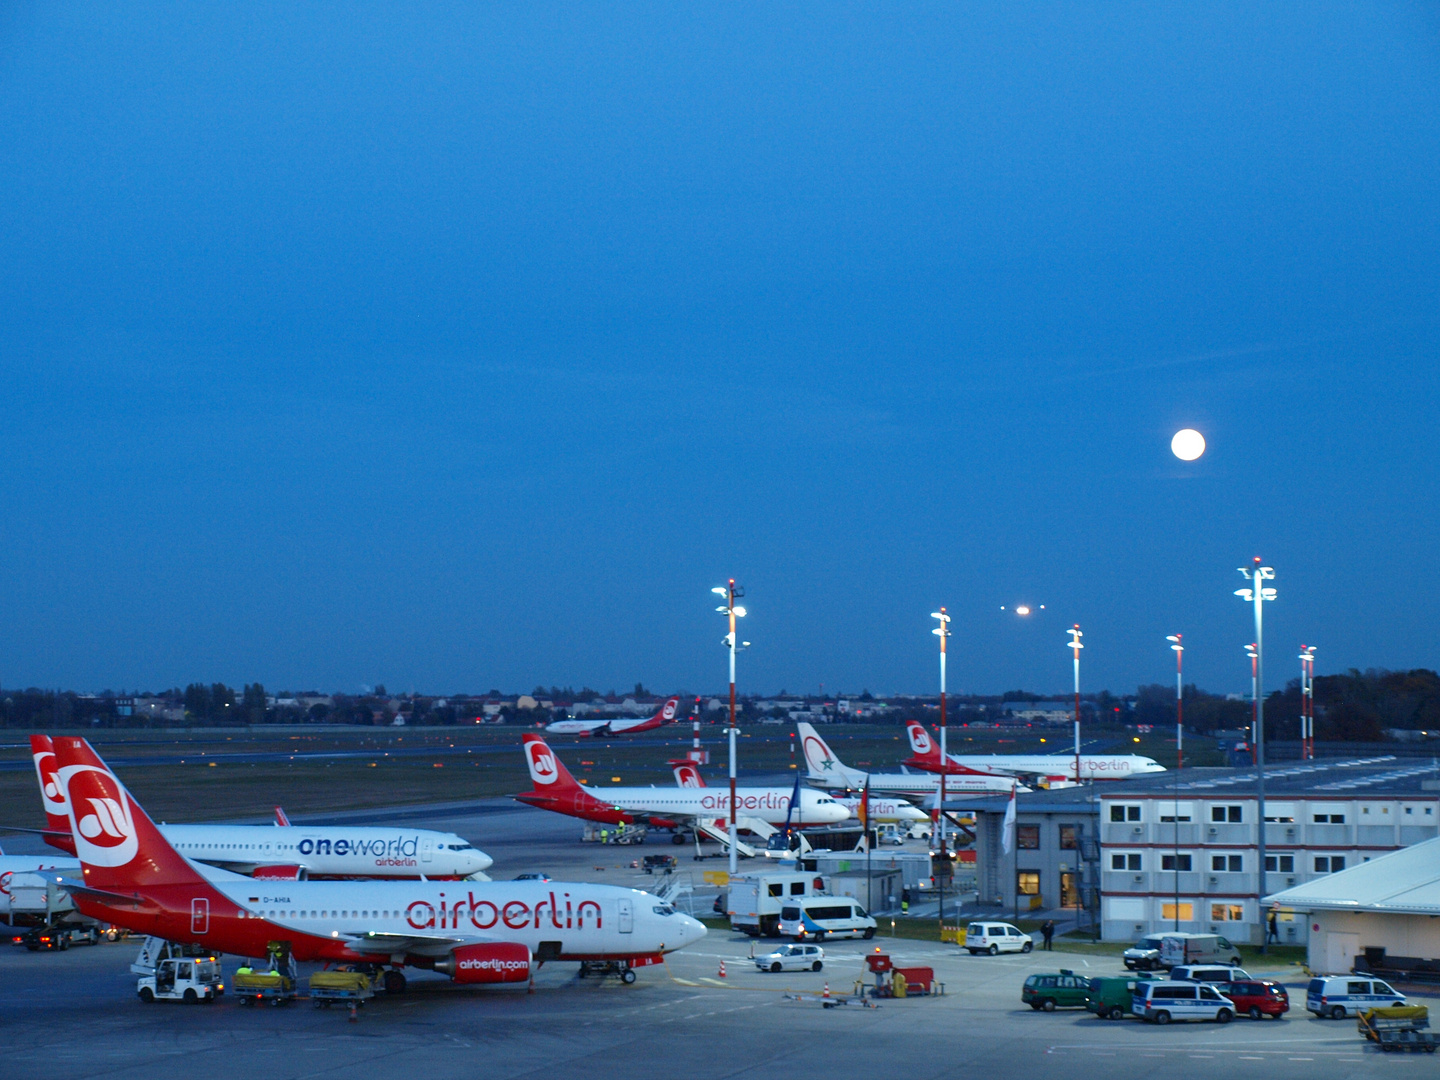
(39, 736), (706, 994)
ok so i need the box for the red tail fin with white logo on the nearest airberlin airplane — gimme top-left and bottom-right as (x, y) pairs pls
(55, 737), (204, 890)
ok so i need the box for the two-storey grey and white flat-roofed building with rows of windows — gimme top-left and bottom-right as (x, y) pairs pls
(952, 757), (1440, 945)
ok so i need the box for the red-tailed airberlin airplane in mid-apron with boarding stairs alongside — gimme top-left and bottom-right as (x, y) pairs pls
(513, 734), (850, 854)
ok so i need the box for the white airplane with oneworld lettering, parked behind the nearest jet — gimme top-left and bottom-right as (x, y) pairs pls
(30, 734), (494, 881)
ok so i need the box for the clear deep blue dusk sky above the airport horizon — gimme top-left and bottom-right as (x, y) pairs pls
(0, 3), (1440, 693)
